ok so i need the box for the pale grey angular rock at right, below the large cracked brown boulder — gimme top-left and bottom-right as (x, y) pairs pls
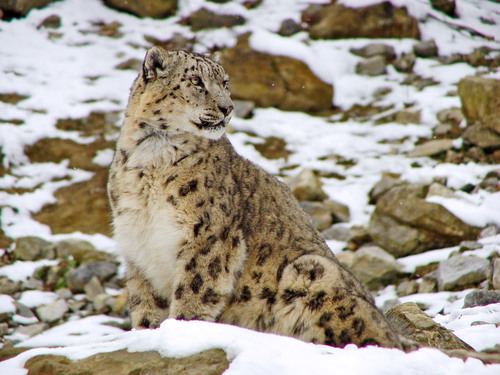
(437, 255), (490, 291)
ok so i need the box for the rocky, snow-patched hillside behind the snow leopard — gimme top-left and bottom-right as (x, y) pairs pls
(0, 0), (500, 374)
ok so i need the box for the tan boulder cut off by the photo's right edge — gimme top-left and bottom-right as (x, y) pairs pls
(458, 76), (500, 149)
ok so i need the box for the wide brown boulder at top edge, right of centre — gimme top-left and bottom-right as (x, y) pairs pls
(309, 1), (420, 39)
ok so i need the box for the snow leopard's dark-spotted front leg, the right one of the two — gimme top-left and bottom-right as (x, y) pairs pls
(169, 231), (246, 321)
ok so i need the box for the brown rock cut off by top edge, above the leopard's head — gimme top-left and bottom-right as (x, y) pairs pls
(104, 0), (177, 18)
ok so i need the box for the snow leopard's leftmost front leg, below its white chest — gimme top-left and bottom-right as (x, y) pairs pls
(126, 262), (170, 329)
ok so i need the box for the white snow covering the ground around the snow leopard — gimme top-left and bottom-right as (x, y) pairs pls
(0, 0), (500, 375)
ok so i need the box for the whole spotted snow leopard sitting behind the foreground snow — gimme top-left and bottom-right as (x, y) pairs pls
(108, 47), (400, 347)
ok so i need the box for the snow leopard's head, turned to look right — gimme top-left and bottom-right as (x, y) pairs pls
(127, 47), (234, 139)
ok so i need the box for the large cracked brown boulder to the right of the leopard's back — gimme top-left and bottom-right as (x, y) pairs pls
(369, 184), (479, 258)
